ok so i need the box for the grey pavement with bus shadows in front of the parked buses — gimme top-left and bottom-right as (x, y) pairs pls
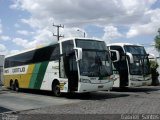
(0, 86), (160, 120)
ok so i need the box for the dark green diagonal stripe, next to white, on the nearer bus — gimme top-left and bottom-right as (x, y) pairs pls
(34, 61), (49, 89)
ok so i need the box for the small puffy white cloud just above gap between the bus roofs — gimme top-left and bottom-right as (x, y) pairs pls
(102, 25), (123, 43)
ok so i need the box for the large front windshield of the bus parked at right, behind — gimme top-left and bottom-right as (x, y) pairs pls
(124, 46), (150, 75)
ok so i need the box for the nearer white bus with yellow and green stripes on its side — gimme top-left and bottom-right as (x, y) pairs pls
(4, 38), (117, 96)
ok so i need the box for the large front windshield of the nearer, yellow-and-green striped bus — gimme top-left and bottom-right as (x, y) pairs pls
(76, 40), (112, 77)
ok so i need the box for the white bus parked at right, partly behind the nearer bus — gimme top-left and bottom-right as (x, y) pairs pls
(108, 43), (152, 87)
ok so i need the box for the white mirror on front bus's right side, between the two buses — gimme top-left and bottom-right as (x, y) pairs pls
(110, 50), (120, 62)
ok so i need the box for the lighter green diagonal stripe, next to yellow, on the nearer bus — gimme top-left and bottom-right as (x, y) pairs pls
(29, 63), (41, 88)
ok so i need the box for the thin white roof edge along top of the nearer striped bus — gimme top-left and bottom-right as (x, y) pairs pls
(5, 37), (103, 58)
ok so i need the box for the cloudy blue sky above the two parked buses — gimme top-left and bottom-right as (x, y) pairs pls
(0, 0), (160, 56)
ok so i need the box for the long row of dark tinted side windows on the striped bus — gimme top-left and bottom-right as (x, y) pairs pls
(5, 44), (60, 67)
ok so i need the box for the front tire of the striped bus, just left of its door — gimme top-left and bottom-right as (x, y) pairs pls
(52, 80), (61, 97)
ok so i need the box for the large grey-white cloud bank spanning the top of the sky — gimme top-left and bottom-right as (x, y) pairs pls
(11, 0), (156, 27)
